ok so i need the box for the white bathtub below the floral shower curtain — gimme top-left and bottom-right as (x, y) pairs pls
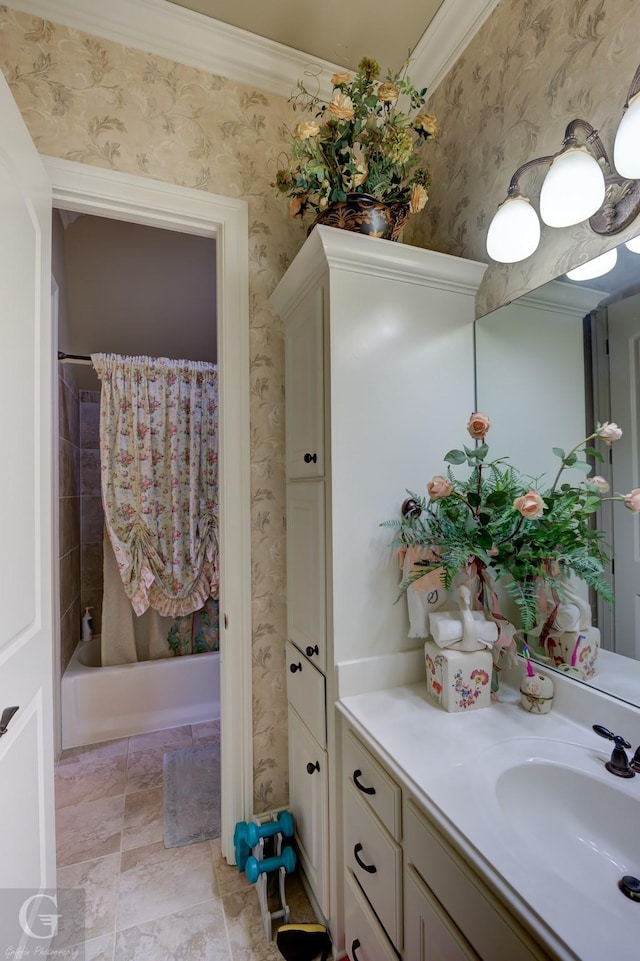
(61, 637), (220, 748)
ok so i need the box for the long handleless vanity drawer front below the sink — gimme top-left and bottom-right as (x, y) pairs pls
(404, 800), (548, 961)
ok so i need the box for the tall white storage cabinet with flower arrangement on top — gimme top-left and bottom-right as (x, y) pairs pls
(272, 227), (485, 950)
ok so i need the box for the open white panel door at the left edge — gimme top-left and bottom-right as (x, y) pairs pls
(0, 73), (55, 888)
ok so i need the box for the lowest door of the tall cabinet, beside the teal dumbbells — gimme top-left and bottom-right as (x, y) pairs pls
(289, 705), (329, 916)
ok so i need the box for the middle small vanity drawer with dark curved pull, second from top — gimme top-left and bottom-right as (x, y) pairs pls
(344, 784), (402, 950)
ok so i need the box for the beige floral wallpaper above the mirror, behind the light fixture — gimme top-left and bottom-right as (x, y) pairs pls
(404, 0), (640, 315)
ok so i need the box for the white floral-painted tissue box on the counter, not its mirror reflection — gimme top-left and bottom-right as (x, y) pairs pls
(424, 641), (493, 712)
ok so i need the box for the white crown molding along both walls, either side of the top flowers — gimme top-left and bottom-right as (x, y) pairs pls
(8, 0), (490, 98)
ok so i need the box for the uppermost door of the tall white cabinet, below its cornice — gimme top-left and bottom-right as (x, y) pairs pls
(285, 287), (324, 477)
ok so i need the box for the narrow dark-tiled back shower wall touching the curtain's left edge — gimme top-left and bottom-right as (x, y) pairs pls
(78, 390), (104, 636)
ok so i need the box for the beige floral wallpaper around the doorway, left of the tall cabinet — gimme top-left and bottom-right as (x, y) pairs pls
(0, 6), (304, 812)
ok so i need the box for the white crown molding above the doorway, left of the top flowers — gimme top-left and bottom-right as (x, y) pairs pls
(8, 0), (343, 98)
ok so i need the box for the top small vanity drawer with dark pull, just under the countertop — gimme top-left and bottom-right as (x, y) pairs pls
(342, 731), (402, 841)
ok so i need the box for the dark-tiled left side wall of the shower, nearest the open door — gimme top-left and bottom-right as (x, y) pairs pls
(58, 364), (82, 673)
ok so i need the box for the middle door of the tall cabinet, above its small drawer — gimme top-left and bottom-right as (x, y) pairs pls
(287, 480), (327, 673)
